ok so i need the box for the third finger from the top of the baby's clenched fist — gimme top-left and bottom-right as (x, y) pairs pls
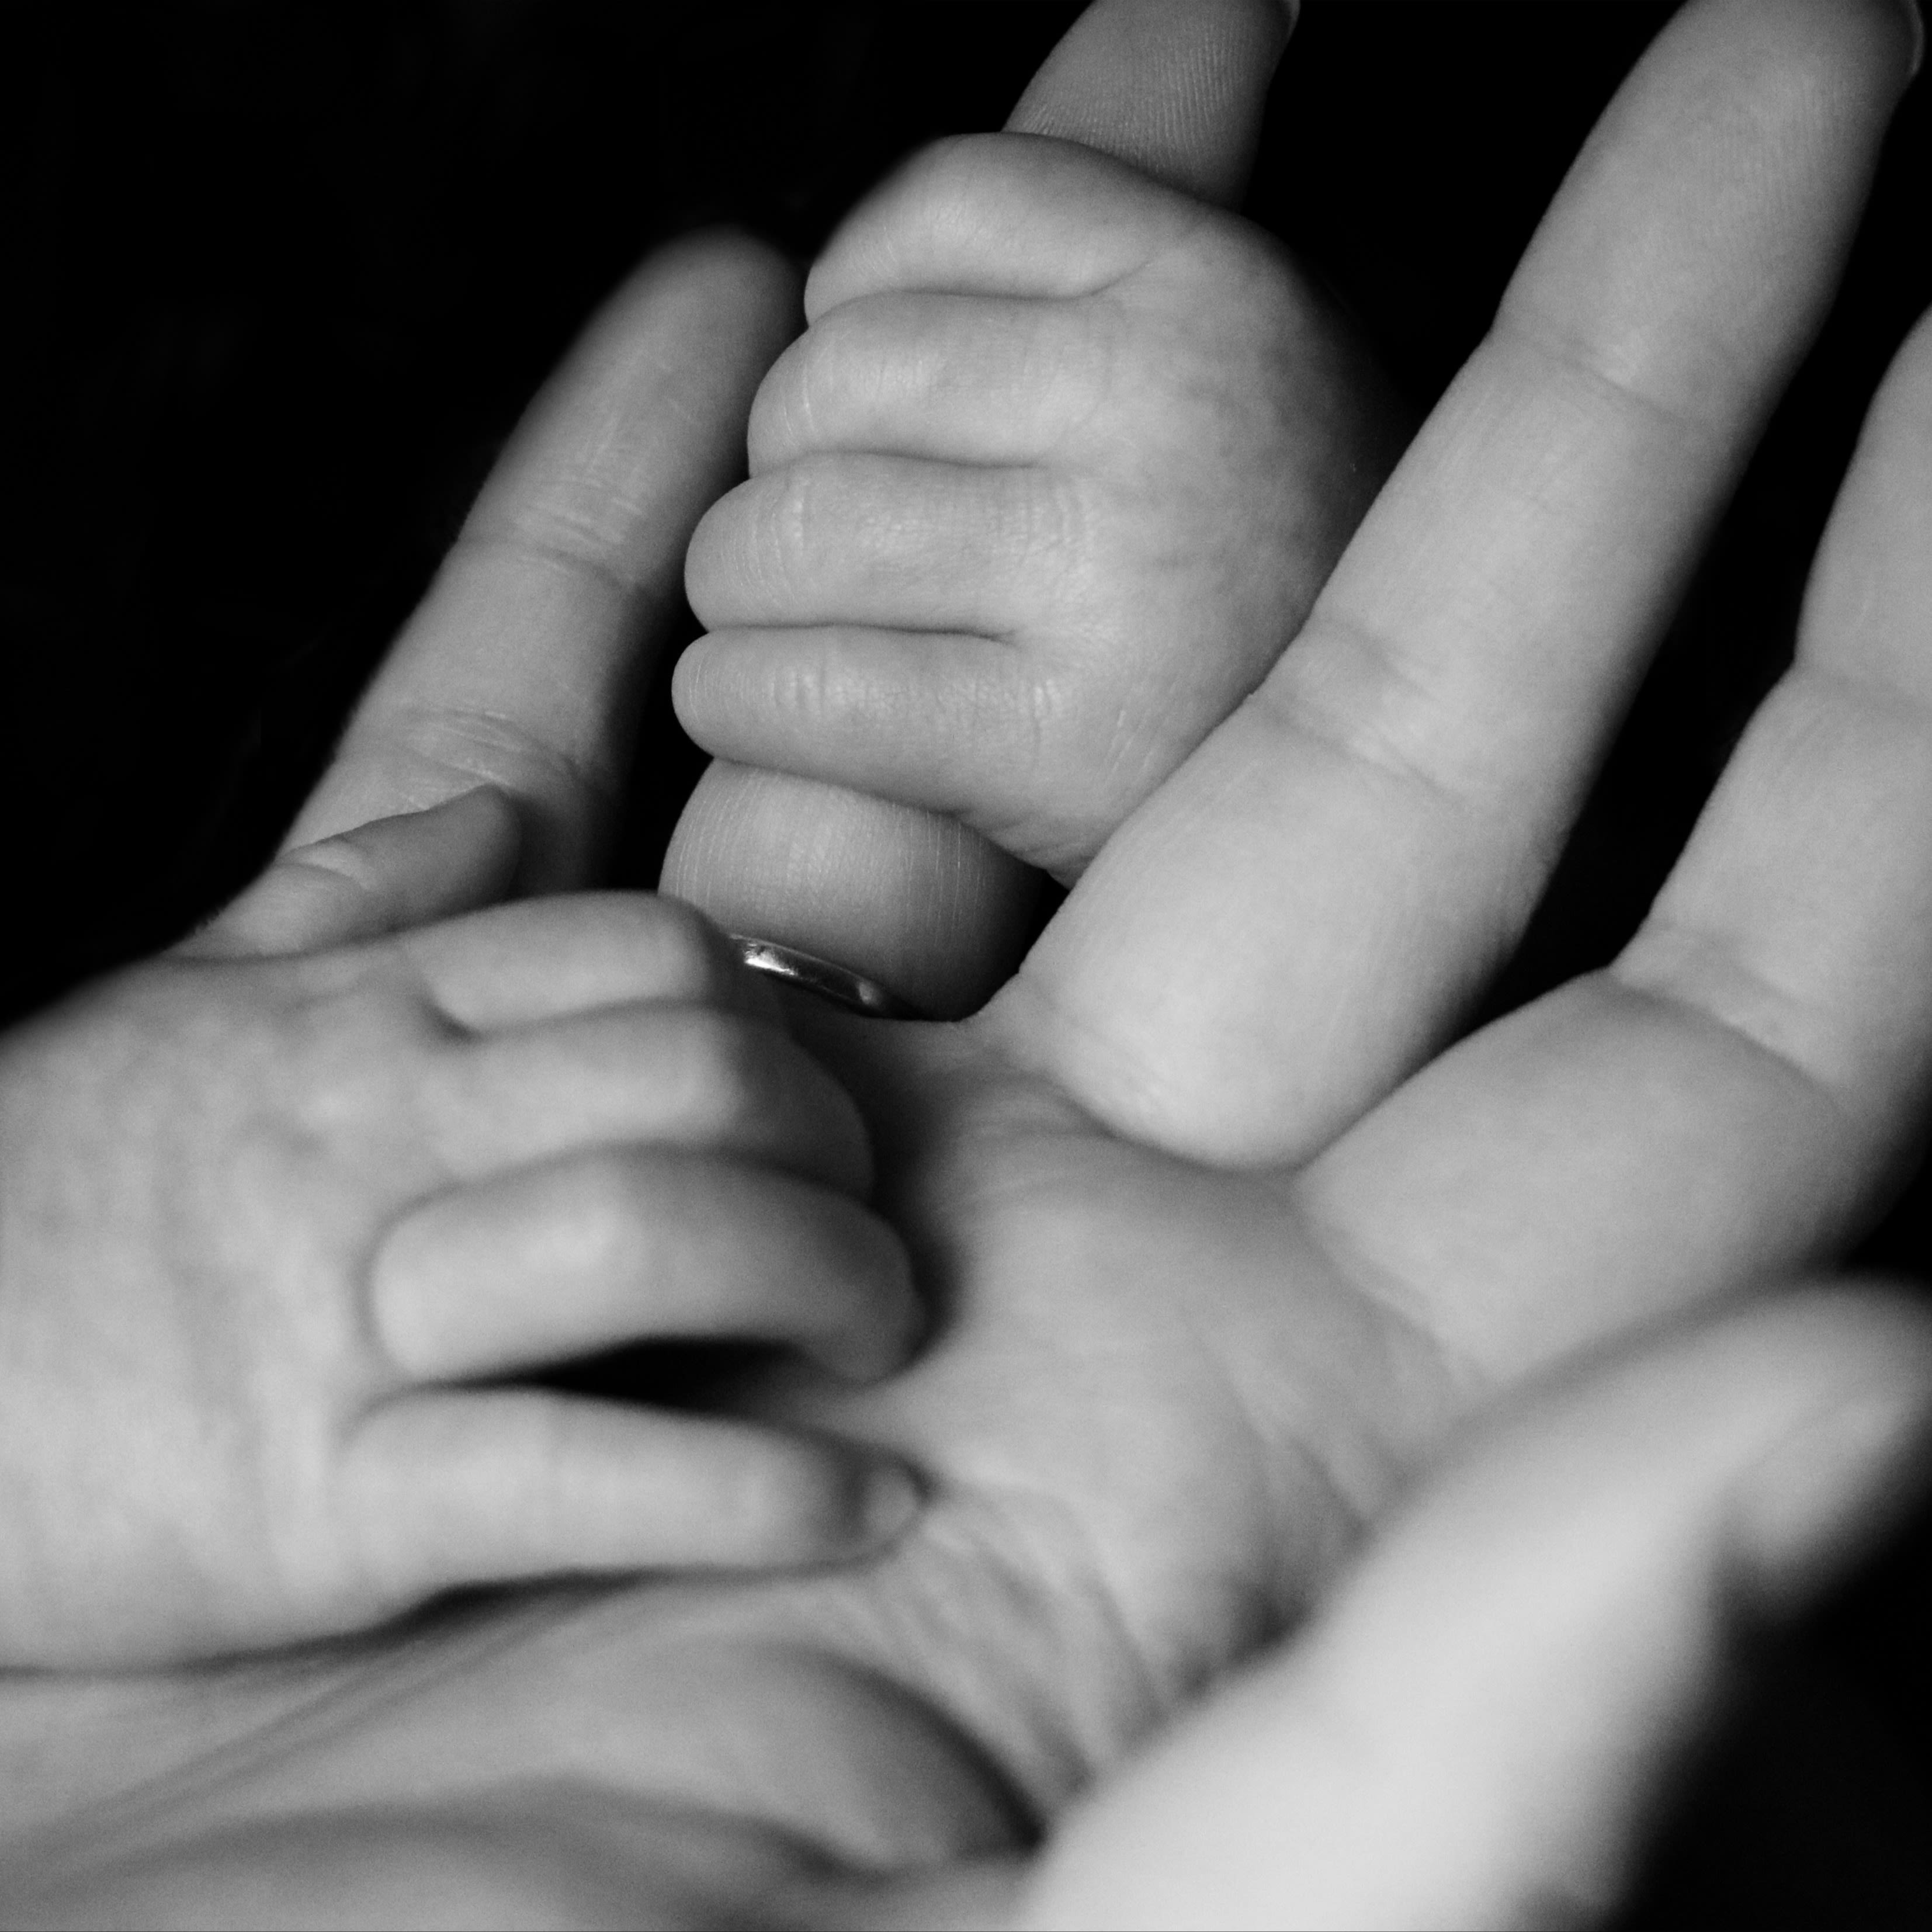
(684, 450), (1088, 637)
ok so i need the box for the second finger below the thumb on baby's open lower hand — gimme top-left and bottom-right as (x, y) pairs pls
(421, 1001), (871, 1194)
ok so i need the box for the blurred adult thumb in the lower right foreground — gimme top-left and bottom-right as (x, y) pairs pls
(1018, 1291), (1932, 1926)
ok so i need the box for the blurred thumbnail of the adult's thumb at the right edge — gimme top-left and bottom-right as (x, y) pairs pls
(1737, 1389), (1932, 1602)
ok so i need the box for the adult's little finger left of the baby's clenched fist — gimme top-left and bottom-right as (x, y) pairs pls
(290, 235), (796, 889)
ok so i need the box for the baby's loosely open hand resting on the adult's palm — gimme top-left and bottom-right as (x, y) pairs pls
(0, 827), (918, 1663)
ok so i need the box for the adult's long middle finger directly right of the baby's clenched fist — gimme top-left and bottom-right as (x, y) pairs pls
(1005, 0), (1913, 1161)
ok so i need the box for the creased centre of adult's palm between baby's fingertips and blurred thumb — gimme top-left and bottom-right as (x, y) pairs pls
(726, 1030), (1391, 1808)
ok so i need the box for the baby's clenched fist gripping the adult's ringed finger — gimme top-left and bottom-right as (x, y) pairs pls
(667, 133), (1399, 885)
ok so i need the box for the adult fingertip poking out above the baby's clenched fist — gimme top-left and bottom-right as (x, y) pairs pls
(1007, 0), (1295, 207)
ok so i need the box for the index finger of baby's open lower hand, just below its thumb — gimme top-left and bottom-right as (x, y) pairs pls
(400, 893), (779, 1030)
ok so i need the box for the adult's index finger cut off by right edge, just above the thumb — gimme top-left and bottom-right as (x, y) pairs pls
(1298, 309), (1932, 1372)
